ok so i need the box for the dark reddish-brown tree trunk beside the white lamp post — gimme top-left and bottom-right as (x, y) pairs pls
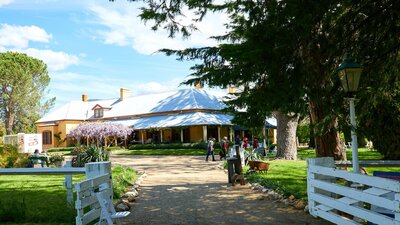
(310, 101), (347, 160)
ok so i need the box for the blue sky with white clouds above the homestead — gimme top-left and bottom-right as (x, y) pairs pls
(0, 0), (230, 109)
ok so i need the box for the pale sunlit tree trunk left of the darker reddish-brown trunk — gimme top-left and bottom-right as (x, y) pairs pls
(276, 113), (299, 160)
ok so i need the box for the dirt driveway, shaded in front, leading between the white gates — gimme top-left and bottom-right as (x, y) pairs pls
(112, 155), (330, 225)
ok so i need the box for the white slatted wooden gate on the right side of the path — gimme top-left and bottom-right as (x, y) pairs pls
(307, 158), (400, 225)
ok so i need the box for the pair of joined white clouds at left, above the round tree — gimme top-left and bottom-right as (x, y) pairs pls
(0, 24), (79, 71)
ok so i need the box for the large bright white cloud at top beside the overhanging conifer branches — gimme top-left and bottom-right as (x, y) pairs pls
(89, 3), (227, 54)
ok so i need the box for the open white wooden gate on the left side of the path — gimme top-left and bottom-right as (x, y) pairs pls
(75, 162), (113, 225)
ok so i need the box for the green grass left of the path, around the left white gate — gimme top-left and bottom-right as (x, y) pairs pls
(0, 166), (137, 225)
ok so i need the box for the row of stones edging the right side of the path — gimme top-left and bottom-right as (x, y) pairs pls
(217, 164), (308, 213)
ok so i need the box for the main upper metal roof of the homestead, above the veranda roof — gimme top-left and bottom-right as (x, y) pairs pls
(36, 89), (225, 123)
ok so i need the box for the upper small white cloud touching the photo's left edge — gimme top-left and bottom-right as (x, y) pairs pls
(0, 24), (52, 49)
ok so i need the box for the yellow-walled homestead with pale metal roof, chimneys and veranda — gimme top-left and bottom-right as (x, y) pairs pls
(36, 86), (274, 148)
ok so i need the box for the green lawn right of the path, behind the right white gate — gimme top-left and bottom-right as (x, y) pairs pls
(247, 148), (390, 199)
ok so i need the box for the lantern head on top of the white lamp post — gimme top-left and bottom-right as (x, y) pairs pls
(338, 58), (362, 92)
